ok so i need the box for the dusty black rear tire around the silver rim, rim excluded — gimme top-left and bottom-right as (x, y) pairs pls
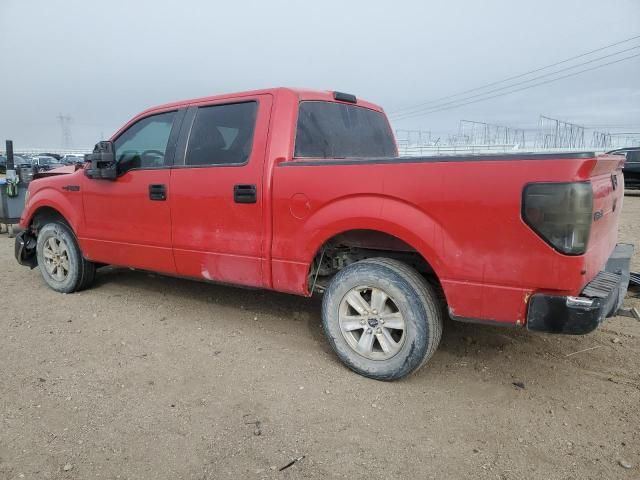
(322, 258), (442, 380)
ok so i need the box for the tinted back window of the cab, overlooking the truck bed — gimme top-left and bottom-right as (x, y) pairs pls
(295, 101), (396, 158)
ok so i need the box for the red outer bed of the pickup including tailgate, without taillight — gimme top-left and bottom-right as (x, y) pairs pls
(273, 152), (622, 323)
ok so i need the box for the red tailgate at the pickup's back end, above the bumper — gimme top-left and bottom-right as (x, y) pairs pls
(585, 155), (624, 284)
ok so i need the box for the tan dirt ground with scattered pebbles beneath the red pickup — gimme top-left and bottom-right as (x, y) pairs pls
(0, 196), (640, 480)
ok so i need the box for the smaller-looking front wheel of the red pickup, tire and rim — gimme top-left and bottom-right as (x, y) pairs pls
(36, 221), (96, 293)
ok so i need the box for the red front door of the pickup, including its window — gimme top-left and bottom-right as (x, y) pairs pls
(79, 111), (184, 273)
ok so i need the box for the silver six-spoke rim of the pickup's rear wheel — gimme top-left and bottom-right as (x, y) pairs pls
(338, 286), (406, 360)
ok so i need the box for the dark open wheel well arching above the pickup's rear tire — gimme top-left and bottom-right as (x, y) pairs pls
(307, 230), (444, 298)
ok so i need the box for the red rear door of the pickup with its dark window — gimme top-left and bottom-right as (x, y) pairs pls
(169, 95), (272, 286)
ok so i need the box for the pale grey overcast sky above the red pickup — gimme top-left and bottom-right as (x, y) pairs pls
(0, 0), (640, 150)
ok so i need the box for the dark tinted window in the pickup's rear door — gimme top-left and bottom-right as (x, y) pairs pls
(185, 102), (258, 165)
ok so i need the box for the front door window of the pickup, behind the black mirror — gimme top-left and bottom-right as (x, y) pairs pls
(114, 112), (176, 173)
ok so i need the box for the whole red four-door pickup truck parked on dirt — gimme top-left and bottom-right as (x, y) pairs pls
(16, 88), (633, 380)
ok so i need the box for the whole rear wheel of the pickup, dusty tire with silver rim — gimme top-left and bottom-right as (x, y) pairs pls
(322, 258), (442, 380)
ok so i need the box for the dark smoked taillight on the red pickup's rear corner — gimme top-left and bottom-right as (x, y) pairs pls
(522, 182), (593, 255)
